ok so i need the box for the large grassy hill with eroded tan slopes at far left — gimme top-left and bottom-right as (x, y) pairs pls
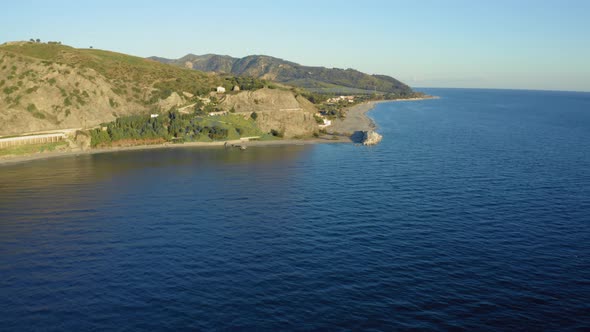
(0, 42), (236, 135)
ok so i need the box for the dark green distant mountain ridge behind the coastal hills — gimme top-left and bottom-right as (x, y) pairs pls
(150, 54), (413, 96)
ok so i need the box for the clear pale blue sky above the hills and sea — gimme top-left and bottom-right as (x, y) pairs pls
(0, 0), (590, 91)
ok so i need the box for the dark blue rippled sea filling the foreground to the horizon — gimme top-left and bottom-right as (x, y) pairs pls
(0, 89), (590, 331)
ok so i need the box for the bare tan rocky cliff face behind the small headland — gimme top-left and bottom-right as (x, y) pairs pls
(221, 89), (318, 138)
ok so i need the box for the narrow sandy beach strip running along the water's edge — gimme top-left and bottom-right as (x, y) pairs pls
(0, 96), (438, 166)
